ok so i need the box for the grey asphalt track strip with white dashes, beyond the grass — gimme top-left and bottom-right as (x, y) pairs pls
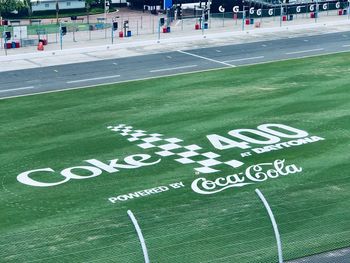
(0, 32), (350, 98)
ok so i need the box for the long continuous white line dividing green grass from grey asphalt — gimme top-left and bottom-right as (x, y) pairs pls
(0, 50), (349, 100)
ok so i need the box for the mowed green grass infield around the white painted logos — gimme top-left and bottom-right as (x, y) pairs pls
(0, 53), (350, 263)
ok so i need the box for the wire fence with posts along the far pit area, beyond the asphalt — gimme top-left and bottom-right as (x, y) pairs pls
(0, 6), (350, 53)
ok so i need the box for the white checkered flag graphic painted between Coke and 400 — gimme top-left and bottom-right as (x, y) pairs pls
(108, 124), (243, 173)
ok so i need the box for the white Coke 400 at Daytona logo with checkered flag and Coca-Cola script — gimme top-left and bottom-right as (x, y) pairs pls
(17, 123), (324, 194)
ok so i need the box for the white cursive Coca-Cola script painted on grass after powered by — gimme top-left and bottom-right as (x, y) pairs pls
(191, 160), (303, 195)
